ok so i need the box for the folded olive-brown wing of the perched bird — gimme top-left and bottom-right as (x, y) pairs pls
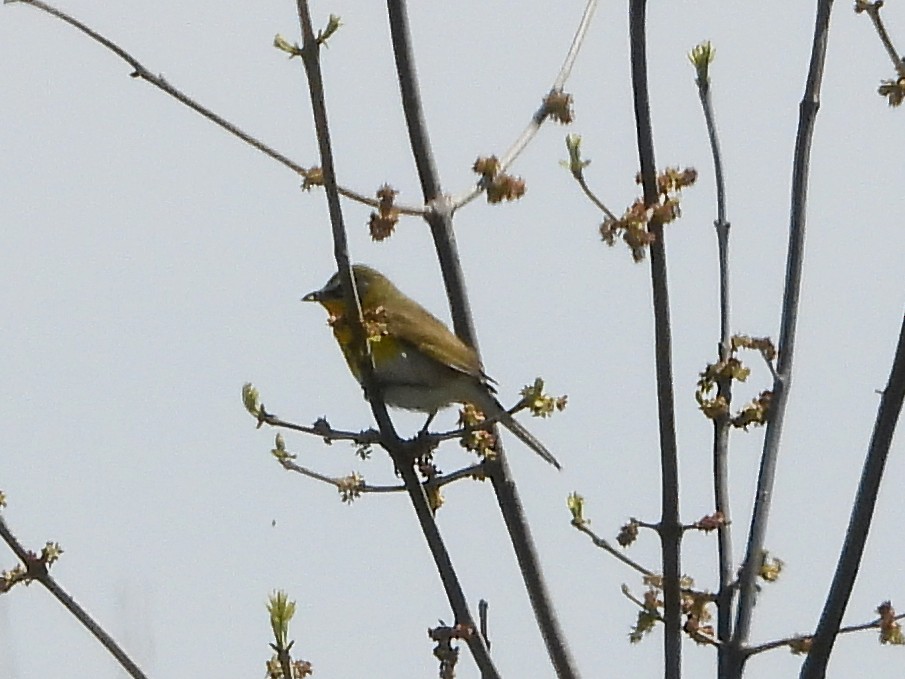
(385, 298), (486, 380)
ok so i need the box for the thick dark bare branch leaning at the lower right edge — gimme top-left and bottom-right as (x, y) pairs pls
(799, 317), (905, 679)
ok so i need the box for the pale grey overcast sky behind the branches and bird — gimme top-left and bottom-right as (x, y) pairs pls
(0, 0), (905, 679)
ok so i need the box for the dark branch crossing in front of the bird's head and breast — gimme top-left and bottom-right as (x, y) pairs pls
(297, 0), (499, 679)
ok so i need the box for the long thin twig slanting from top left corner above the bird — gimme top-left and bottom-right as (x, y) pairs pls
(5, 0), (426, 216)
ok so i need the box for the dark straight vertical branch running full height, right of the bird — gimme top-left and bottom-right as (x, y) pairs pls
(629, 0), (682, 679)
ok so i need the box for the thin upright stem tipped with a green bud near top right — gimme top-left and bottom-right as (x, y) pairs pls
(692, 43), (733, 676)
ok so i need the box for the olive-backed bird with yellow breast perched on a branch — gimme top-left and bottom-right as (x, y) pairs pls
(302, 264), (561, 469)
